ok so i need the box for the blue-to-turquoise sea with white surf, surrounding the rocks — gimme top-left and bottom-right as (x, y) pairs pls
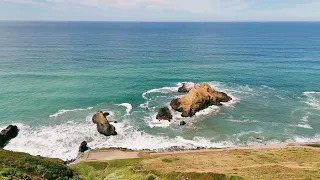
(0, 22), (320, 159)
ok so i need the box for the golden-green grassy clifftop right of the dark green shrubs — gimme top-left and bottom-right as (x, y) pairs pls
(71, 147), (320, 180)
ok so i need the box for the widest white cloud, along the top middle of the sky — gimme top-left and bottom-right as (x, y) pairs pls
(47, 0), (254, 14)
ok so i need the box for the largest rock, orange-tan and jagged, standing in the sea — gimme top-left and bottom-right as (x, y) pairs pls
(170, 83), (232, 117)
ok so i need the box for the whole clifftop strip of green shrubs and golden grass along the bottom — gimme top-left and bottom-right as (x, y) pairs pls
(0, 144), (320, 180)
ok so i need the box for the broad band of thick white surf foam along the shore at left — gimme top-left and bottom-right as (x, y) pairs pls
(1, 120), (236, 160)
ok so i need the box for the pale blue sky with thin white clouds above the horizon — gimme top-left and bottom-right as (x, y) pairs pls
(0, 0), (320, 22)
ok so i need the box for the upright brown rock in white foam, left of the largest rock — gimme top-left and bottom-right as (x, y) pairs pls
(92, 111), (117, 136)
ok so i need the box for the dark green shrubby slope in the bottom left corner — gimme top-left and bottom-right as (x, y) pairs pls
(0, 149), (77, 180)
